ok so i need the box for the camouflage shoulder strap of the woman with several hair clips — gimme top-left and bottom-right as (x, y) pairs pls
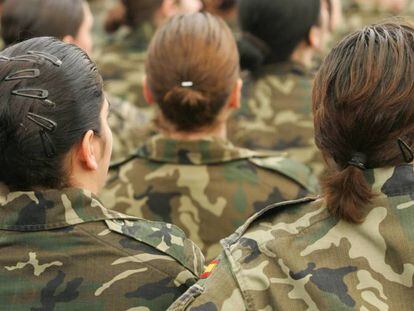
(105, 219), (204, 276)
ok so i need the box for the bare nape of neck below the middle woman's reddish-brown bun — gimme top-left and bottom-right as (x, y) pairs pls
(161, 122), (227, 141)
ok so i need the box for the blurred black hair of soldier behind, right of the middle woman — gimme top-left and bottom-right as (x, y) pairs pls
(238, 0), (321, 71)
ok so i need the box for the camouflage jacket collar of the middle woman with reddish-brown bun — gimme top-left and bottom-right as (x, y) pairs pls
(137, 135), (260, 165)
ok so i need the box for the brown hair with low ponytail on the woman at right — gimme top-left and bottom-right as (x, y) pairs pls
(313, 22), (414, 222)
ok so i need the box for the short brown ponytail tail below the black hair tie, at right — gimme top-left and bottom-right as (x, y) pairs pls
(321, 165), (374, 223)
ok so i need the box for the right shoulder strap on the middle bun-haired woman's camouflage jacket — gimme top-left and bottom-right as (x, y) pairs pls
(249, 153), (319, 193)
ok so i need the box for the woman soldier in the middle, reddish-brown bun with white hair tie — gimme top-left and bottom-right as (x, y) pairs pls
(104, 13), (314, 259)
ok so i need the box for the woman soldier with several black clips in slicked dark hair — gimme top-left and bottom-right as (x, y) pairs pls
(0, 37), (203, 310)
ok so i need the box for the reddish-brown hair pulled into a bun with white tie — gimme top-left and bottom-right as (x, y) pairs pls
(146, 13), (240, 132)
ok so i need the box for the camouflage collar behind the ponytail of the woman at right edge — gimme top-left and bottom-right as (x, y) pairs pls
(365, 164), (414, 198)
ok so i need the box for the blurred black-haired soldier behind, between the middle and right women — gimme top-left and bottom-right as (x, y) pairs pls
(229, 0), (330, 173)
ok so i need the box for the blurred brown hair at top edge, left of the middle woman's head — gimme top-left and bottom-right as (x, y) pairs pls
(105, 0), (163, 33)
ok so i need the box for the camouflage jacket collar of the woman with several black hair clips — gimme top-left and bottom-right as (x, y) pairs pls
(0, 188), (133, 231)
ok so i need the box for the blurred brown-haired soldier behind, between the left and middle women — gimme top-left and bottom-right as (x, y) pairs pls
(100, 0), (202, 111)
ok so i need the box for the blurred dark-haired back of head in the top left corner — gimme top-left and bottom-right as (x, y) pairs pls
(1, 0), (85, 45)
